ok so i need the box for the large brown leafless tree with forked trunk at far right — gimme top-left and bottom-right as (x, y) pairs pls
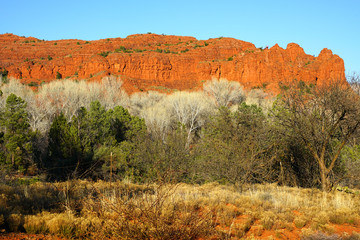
(275, 82), (360, 191)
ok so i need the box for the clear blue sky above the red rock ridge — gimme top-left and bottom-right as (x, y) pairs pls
(0, 0), (360, 73)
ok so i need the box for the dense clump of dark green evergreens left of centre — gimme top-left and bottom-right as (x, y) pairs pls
(47, 101), (146, 179)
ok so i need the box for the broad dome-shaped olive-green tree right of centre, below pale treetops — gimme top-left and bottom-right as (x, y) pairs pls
(194, 103), (277, 183)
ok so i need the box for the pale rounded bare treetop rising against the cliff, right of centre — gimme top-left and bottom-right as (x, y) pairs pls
(204, 78), (245, 107)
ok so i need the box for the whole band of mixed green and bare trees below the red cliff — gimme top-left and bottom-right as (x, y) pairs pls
(0, 77), (360, 190)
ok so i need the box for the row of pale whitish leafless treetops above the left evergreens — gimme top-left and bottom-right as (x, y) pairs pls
(0, 76), (128, 132)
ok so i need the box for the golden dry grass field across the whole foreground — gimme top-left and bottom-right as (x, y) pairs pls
(0, 180), (360, 239)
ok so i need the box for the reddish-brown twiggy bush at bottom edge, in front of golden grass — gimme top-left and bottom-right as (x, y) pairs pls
(89, 184), (214, 239)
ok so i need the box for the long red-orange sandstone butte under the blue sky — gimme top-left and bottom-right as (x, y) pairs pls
(0, 34), (346, 93)
